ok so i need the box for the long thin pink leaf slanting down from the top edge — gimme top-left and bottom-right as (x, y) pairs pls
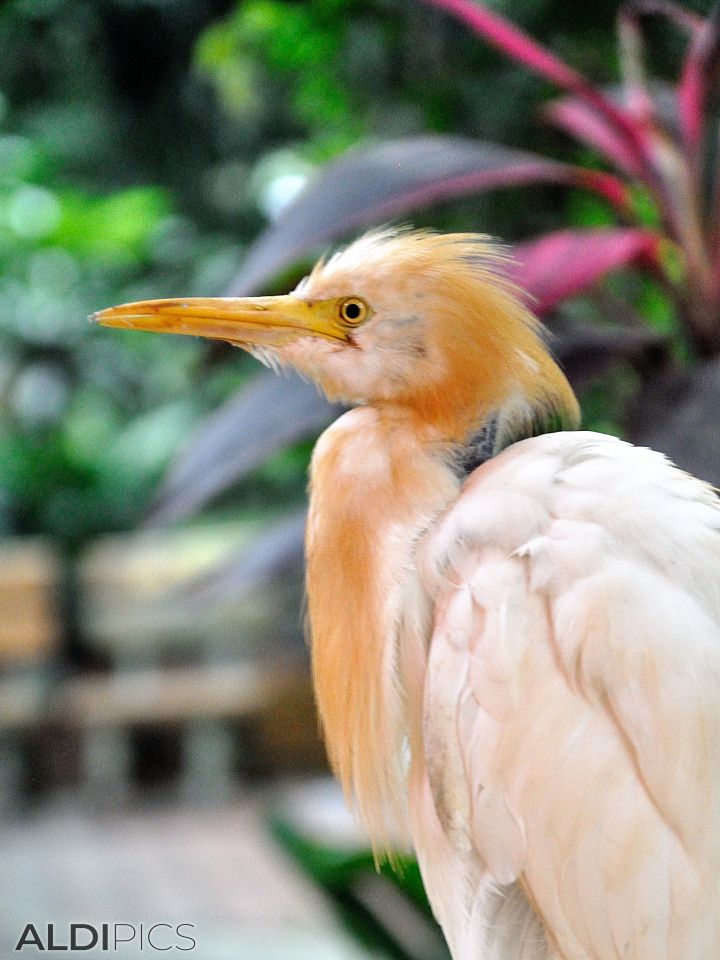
(424, 0), (645, 172)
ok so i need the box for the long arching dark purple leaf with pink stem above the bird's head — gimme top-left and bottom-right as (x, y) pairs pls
(228, 135), (628, 296)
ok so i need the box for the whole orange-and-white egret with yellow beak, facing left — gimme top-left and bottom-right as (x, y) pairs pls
(94, 227), (720, 960)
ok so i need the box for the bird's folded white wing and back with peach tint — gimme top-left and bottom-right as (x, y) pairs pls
(414, 433), (720, 960)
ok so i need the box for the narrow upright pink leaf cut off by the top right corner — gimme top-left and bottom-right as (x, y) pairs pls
(678, 3), (720, 157)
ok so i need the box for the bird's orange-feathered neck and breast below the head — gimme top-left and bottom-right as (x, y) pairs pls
(307, 407), (460, 848)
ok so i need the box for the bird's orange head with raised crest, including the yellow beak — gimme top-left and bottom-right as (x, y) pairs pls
(94, 230), (577, 439)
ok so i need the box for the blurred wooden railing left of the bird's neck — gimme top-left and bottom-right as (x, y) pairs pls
(0, 527), (323, 806)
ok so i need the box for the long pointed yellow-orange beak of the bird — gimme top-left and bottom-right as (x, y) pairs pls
(90, 295), (349, 346)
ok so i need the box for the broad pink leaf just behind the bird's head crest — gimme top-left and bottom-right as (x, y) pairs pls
(510, 227), (661, 315)
